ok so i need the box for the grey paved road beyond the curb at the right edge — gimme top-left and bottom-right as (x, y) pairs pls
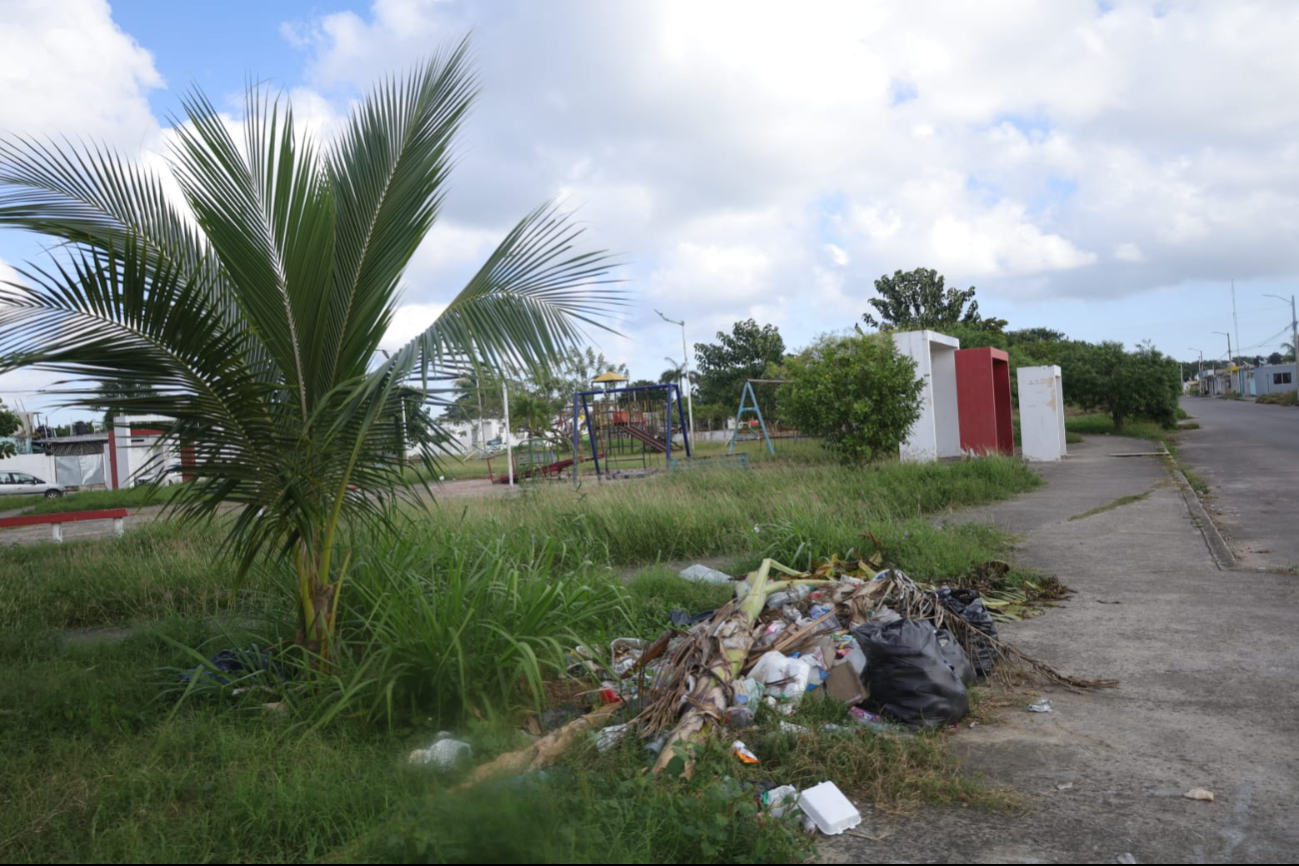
(1178, 397), (1299, 571)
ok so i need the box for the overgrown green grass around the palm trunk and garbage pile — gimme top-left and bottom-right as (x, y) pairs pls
(0, 452), (1039, 862)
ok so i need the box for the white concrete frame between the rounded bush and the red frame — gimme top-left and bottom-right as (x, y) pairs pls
(892, 331), (961, 462)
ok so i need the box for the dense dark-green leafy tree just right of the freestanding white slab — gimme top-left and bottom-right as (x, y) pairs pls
(1060, 341), (1182, 431)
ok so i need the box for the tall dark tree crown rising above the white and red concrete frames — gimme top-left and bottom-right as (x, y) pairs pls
(861, 267), (1007, 331)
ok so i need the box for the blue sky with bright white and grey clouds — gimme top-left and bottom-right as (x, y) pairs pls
(0, 0), (1299, 419)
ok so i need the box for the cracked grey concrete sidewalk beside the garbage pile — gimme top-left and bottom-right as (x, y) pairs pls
(822, 436), (1299, 863)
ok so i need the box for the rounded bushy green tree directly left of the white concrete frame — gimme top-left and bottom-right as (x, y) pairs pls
(779, 334), (924, 465)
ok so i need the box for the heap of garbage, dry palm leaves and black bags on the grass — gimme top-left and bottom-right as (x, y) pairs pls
(597, 560), (1116, 771)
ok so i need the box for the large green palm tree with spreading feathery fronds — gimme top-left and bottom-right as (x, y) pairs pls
(0, 43), (622, 656)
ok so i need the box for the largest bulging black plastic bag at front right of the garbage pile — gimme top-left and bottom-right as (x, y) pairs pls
(852, 619), (970, 727)
